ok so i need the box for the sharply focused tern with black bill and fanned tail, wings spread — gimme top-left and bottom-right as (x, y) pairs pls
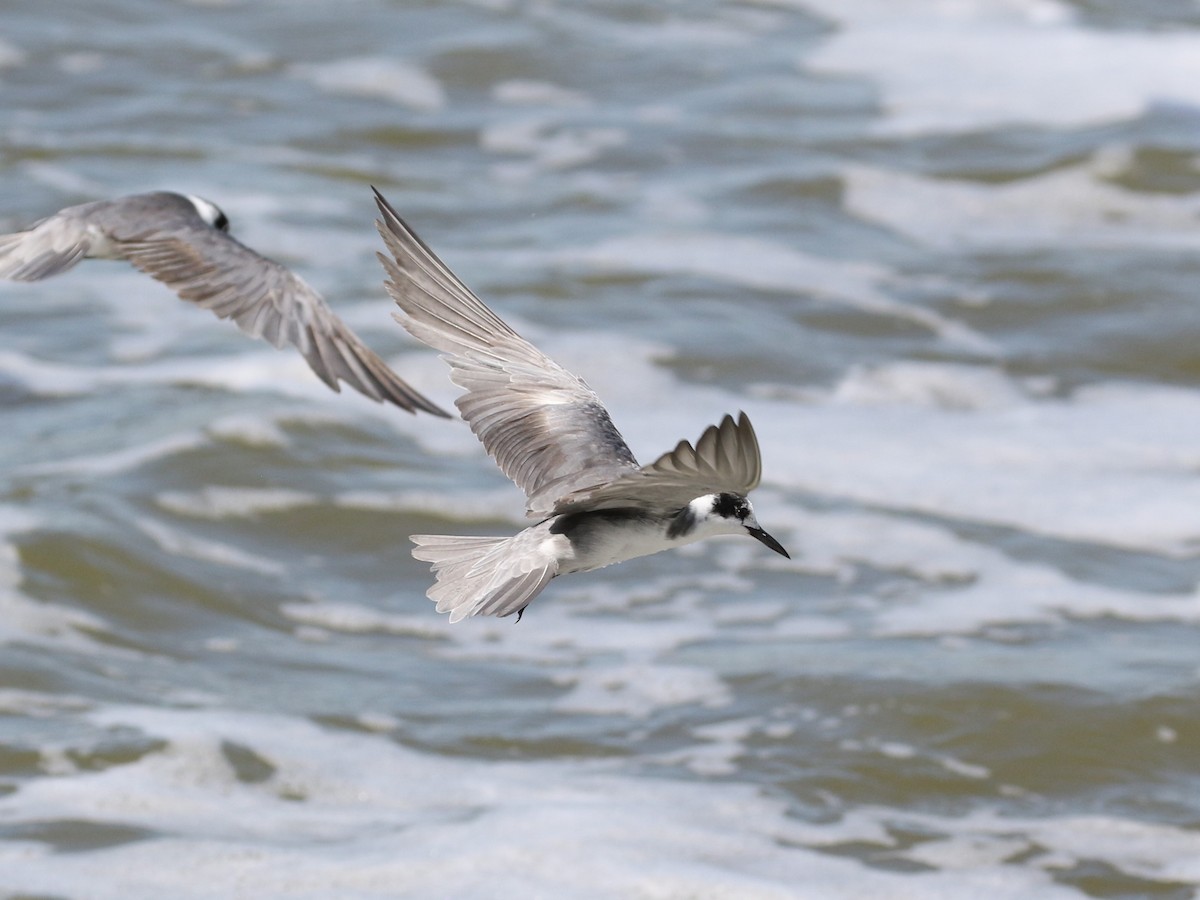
(376, 191), (787, 622)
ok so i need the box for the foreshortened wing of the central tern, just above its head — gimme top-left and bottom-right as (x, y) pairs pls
(553, 413), (762, 514)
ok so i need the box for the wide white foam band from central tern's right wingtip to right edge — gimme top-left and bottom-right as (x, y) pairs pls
(744, 365), (1200, 556)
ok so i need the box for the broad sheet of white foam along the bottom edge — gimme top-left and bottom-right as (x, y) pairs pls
(0, 707), (1200, 900)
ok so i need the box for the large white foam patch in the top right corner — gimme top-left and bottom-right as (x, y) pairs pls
(800, 0), (1200, 134)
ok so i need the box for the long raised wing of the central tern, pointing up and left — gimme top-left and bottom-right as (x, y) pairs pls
(376, 191), (637, 516)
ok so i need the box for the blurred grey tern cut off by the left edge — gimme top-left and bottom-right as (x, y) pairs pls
(0, 191), (449, 418)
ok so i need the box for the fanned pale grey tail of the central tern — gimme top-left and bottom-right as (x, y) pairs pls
(412, 529), (558, 622)
